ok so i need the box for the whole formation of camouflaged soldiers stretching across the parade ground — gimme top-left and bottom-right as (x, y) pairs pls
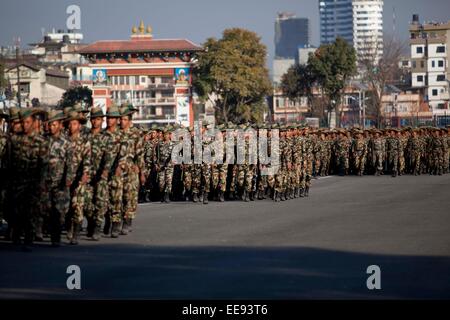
(0, 105), (450, 248)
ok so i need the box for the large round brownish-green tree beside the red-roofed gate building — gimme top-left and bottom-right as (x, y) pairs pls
(193, 28), (271, 123)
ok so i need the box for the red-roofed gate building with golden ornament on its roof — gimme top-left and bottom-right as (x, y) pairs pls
(79, 21), (202, 125)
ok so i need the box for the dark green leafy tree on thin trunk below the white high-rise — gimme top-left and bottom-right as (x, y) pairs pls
(308, 38), (356, 127)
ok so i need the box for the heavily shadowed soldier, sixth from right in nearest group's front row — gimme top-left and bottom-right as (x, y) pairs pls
(7, 108), (47, 251)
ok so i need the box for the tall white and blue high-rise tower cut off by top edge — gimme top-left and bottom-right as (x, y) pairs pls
(319, 0), (383, 60)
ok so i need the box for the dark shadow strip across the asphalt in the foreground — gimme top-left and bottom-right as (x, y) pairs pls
(0, 242), (450, 299)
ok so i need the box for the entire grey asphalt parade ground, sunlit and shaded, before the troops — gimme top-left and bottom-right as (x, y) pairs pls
(0, 174), (450, 299)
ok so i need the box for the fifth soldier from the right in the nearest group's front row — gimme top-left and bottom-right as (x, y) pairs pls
(41, 110), (75, 247)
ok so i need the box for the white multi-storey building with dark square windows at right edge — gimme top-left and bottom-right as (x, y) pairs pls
(409, 15), (450, 116)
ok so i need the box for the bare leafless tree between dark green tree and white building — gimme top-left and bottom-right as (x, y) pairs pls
(358, 37), (406, 127)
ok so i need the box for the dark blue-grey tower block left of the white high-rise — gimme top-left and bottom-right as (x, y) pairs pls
(275, 12), (311, 59)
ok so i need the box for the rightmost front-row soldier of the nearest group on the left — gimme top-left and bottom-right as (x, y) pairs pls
(118, 106), (146, 235)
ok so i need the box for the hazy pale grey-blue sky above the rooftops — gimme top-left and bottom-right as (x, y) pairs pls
(0, 0), (450, 70)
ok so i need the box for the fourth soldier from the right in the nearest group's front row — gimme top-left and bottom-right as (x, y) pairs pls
(65, 111), (92, 245)
